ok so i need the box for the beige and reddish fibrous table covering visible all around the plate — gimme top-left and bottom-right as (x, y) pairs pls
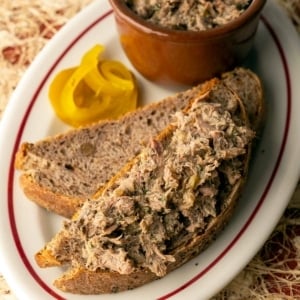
(0, 0), (300, 300)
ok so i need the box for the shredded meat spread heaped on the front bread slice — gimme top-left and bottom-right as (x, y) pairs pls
(53, 93), (254, 276)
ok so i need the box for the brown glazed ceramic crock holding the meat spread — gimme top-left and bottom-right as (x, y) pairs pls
(110, 0), (266, 85)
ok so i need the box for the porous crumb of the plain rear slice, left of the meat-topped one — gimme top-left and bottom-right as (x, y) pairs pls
(16, 89), (197, 197)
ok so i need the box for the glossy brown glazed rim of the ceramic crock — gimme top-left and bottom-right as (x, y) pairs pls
(109, 0), (267, 41)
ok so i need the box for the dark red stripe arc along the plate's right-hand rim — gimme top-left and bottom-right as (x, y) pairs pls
(157, 16), (292, 300)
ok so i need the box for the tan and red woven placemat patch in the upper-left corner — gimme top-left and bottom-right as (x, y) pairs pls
(0, 0), (92, 118)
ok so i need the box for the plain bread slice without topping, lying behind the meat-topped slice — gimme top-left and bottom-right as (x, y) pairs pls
(15, 68), (264, 217)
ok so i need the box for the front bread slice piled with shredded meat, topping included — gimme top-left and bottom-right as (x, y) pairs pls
(36, 79), (254, 294)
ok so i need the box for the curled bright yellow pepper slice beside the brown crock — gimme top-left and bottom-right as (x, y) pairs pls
(49, 45), (138, 127)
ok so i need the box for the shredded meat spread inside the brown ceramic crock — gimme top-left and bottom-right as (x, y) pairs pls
(125, 0), (251, 31)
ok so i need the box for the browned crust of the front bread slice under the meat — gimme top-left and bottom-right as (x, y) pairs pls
(36, 79), (252, 294)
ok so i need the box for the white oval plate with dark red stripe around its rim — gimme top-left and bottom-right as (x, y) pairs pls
(0, 1), (300, 300)
